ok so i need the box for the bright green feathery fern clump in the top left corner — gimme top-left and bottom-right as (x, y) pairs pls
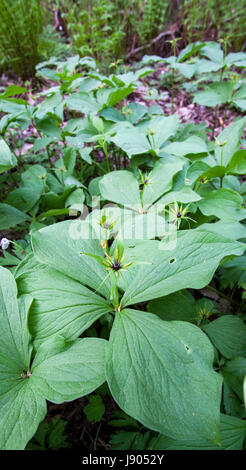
(0, 0), (71, 80)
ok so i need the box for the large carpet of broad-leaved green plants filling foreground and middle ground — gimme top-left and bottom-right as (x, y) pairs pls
(0, 45), (246, 449)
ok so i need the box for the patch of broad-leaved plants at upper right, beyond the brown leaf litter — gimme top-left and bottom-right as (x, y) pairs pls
(139, 38), (246, 127)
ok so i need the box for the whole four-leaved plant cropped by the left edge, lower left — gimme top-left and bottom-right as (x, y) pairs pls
(0, 268), (107, 450)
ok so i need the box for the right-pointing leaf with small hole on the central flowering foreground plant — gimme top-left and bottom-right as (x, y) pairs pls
(122, 230), (244, 307)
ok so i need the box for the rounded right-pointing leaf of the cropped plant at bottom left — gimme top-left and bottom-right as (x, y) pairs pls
(30, 337), (107, 403)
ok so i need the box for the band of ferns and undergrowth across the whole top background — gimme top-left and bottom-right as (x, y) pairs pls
(0, 0), (245, 79)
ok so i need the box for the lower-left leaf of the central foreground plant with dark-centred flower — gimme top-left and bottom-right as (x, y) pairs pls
(15, 255), (111, 345)
